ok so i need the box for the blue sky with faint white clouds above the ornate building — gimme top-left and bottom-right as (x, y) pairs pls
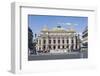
(28, 15), (88, 34)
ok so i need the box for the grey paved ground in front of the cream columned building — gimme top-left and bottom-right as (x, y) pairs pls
(28, 51), (88, 61)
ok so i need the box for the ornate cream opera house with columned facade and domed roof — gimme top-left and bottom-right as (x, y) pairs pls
(36, 26), (80, 53)
